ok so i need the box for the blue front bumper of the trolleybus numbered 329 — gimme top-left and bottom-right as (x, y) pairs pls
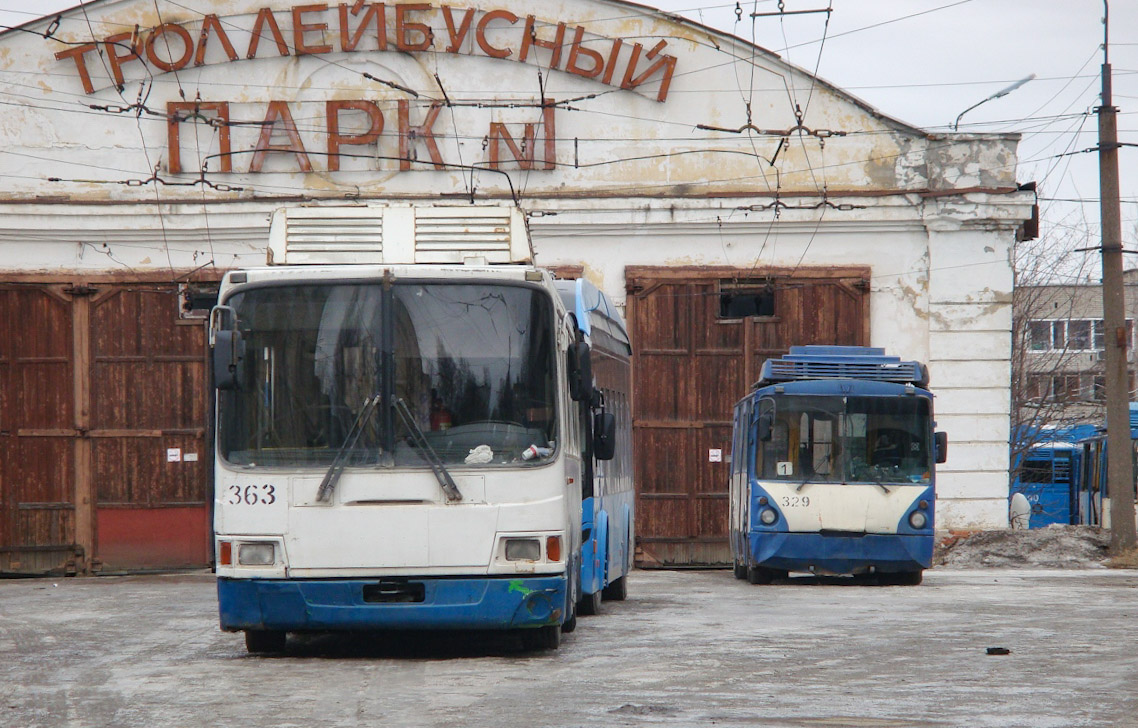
(748, 531), (933, 574)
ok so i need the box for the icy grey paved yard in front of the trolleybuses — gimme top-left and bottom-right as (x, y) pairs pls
(0, 569), (1138, 728)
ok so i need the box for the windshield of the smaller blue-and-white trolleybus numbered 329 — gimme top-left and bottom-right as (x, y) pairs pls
(754, 395), (933, 485)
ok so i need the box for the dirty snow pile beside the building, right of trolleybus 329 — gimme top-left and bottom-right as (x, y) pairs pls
(933, 526), (1121, 569)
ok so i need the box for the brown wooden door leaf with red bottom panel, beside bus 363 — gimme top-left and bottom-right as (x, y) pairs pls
(89, 284), (212, 571)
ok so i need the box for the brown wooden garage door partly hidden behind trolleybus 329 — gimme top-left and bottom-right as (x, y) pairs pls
(626, 267), (869, 566)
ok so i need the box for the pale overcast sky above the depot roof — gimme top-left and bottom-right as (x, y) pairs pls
(0, 0), (1138, 267)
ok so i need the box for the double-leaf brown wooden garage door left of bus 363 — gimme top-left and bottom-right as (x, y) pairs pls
(0, 281), (211, 573)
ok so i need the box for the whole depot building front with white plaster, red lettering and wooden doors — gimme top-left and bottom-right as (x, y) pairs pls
(0, 0), (1033, 572)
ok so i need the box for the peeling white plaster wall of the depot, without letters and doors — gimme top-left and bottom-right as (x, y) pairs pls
(0, 0), (1033, 528)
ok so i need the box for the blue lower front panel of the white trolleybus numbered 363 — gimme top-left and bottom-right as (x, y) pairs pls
(217, 576), (566, 631)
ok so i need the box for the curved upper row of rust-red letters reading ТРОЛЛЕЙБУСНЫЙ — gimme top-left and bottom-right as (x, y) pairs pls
(46, 0), (677, 103)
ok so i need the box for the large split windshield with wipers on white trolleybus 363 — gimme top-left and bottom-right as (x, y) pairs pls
(218, 282), (556, 466)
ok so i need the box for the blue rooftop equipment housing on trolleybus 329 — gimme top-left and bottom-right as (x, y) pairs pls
(754, 346), (929, 387)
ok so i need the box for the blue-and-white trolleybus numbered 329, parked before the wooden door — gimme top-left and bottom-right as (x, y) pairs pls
(729, 346), (948, 585)
